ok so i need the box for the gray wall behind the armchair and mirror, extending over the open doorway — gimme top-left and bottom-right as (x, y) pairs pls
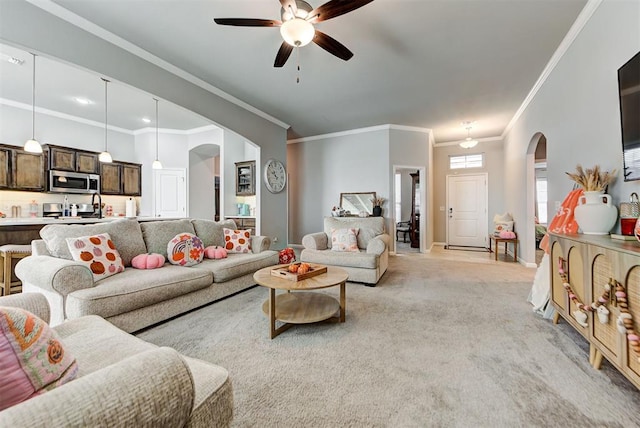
(287, 126), (429, 244)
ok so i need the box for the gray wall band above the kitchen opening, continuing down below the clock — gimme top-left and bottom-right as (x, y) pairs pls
(0, 1), (287, 242)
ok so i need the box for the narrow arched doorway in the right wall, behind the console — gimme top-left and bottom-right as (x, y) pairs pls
(523, 132), (551, 265)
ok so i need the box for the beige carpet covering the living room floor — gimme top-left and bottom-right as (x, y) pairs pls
(138, 255), (640, 427)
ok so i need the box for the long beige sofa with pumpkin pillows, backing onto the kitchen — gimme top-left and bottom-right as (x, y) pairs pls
(15, 219), (278, 332)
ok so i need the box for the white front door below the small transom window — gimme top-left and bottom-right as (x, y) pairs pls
(447, 174), (488, 247)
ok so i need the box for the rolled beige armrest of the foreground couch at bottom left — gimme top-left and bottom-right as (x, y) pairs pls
(0, 348), (195, 427)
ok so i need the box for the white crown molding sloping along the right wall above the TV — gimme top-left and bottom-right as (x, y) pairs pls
(502, 0), (603, 139)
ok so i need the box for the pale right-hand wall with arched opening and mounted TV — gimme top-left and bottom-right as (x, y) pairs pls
(504, 0), (640, 262)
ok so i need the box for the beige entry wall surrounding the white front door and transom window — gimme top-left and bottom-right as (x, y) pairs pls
(433, 141), (504, 242)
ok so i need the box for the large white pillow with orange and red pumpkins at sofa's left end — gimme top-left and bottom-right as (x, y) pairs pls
(67, 233), (124, 281)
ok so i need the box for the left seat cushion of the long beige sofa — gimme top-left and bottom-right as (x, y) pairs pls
(66, 264), (213, 318)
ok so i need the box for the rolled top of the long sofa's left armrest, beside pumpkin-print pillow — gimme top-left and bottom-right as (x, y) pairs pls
(16, 256), (94, 297)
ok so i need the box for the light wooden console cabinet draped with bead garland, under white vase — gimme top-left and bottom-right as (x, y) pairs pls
(549, 233), (640, 388)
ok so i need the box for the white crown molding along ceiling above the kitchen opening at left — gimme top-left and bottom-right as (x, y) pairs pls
(25, 0), (290, 129)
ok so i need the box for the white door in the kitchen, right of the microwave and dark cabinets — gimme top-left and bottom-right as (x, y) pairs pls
(154, 169), (188, 217)
